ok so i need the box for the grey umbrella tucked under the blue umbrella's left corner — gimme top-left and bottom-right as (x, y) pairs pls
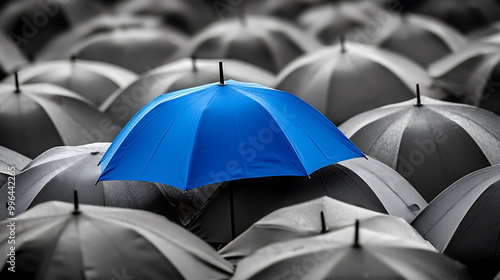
(0, 143), (180, 223)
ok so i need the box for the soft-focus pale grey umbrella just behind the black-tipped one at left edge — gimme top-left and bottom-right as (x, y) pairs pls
(3, 57), (137, 107)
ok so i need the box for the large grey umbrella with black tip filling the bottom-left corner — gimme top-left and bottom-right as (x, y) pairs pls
(0, 202), (233, 280)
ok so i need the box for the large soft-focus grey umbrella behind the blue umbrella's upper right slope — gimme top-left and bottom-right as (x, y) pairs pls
(277, 43), (444, 125)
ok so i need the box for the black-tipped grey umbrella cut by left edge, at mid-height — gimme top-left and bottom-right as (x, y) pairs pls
(0, 80), (120, 158)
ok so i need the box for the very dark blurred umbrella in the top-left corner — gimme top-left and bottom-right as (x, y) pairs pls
(0, 0), (105, 59)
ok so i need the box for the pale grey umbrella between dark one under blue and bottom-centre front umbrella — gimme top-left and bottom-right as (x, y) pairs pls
(219, 197), (435, 263)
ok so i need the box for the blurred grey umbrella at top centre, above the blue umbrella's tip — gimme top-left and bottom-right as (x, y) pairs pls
(184, 15), (320, 73)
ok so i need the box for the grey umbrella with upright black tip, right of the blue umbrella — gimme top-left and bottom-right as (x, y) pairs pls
(340, 97), (500, 201)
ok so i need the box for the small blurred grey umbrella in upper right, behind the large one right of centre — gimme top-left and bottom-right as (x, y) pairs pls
(374, 14), (466, 67)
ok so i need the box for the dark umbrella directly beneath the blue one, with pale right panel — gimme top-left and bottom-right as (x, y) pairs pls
(185, 158), (426, 247)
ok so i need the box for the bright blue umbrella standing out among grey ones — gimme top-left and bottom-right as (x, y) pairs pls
(99, 64), (364, 190)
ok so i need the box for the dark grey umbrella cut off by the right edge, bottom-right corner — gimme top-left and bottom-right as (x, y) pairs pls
(412, 165), (500, 279)
